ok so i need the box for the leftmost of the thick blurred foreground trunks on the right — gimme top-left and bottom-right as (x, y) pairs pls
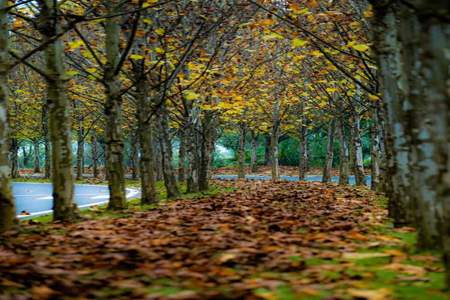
(372, 1), (413, 226)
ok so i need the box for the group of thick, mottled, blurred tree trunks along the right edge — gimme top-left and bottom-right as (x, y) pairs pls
(373, 0), (450, 287)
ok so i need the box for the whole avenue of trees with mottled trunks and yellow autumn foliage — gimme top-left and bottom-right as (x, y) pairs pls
(0, 0), (450, 286)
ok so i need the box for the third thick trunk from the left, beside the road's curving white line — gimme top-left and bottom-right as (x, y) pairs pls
(103, 0), (127, 210)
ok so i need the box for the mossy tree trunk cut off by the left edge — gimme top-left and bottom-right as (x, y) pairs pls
(0, 0), (16, 233)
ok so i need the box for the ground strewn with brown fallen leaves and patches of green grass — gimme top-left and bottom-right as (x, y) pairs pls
(0, 182), (448, 300)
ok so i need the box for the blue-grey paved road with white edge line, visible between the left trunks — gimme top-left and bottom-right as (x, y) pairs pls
(12, 182), (139, 217)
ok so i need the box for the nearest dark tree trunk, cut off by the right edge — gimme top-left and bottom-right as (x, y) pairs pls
(414, 0), (450, 289)
